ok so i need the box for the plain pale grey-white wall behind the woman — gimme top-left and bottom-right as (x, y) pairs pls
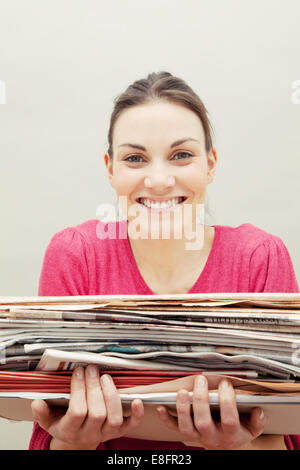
(0, 0), (300, 449)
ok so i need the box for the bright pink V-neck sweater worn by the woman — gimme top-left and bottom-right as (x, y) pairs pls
(29, 220), (300, 450)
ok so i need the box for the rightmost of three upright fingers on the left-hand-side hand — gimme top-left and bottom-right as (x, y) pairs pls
(101, 374), (123, 432)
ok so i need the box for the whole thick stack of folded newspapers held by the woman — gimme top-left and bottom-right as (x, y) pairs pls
(0, 293), (300, 434)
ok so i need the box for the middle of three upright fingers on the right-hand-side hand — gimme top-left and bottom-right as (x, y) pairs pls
(193, 375), (217, 440)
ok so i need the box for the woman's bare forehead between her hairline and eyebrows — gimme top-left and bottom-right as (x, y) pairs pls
(113, 101), (205, 147)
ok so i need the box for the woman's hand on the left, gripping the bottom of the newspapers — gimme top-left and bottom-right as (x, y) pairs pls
(31, 365), (144, 450)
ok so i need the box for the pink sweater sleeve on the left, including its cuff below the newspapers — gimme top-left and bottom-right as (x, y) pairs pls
(29, 228), (88, 450)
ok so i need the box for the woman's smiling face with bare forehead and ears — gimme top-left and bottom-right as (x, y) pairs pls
(105, 101), (217, 239)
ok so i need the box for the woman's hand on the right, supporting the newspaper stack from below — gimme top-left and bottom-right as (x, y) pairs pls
(157, 375), (266, 450)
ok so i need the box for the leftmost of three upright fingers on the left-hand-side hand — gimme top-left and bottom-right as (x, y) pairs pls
(60, 367), (87, 434)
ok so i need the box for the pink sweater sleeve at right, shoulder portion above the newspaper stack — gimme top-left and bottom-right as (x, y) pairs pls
(249, 236), (299, 293)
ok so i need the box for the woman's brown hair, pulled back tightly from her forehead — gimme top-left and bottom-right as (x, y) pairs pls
(107, 72), (213, 159)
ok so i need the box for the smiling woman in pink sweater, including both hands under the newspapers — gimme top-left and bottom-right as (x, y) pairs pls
(30, 72), (299, 450)
